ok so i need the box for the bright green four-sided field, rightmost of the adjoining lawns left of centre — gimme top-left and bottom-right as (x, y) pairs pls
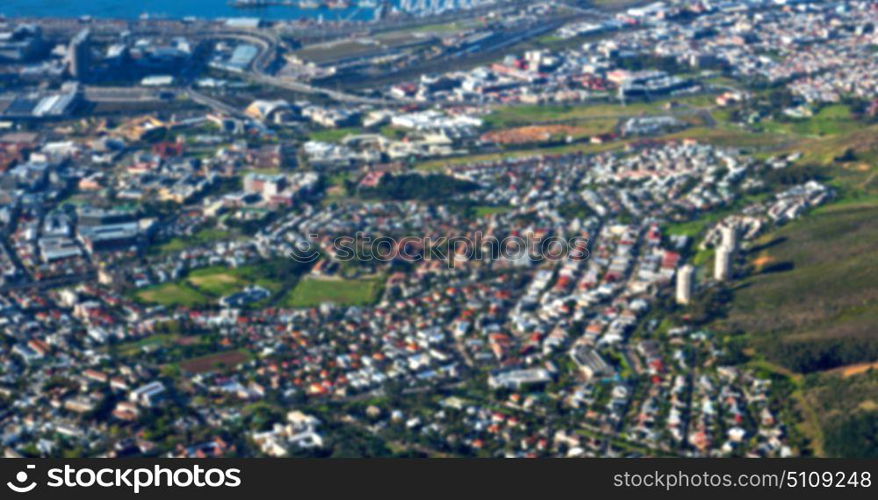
(283, 277), (384, 307)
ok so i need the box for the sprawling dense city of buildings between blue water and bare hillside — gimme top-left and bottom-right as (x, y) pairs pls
(0, 0), (878, 458)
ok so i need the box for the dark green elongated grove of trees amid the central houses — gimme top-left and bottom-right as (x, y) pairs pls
(359, 174), (479, 200)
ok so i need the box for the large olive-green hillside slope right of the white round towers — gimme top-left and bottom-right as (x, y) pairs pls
(728, 199), (878, 340)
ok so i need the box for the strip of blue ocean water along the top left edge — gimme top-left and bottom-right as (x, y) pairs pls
(0, 0), (374, 21)
